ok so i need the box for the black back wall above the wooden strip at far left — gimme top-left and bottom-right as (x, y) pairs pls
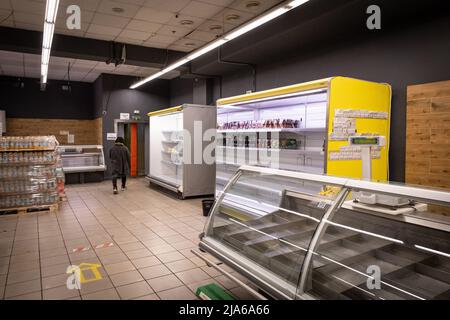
(0, 76), (94, 119)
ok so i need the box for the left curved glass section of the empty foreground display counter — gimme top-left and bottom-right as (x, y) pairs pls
(206, 171), (340, 297)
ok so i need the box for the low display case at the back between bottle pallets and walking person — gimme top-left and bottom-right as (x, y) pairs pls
(57, 145), (106, 184)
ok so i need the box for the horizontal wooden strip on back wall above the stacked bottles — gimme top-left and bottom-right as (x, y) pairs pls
(6, 118), (103, 145)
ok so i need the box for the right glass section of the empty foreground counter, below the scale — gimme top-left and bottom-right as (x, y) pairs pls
(305, 192), (450, 300)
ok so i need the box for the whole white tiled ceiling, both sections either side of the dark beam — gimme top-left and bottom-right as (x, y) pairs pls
(0, 0), (282, 82)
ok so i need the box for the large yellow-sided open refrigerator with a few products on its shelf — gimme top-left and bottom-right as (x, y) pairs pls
(216, 77), (391, 194)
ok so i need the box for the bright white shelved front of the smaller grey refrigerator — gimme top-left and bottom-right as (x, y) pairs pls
(150, 112), (183, 187)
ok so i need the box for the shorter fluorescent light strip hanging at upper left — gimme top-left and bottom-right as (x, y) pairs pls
(41, 0), (59, 90)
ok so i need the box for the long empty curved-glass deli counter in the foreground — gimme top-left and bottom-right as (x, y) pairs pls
(199, 166), (450, 300)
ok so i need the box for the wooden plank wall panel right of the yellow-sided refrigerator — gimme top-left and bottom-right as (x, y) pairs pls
(405, 81), (450, 215)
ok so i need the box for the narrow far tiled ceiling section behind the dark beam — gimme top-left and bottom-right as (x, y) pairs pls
(0, 50), (178, 82)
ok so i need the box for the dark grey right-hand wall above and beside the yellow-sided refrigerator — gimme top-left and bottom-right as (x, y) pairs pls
(204, 18), (450, 181)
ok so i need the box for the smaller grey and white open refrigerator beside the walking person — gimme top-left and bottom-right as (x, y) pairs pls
(148, 104), (216, 198)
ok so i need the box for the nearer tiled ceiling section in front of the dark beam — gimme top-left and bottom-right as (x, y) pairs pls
(0, 0), (282, 52)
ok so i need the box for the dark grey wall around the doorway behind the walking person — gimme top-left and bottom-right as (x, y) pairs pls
(94, 74), (169, 178)
